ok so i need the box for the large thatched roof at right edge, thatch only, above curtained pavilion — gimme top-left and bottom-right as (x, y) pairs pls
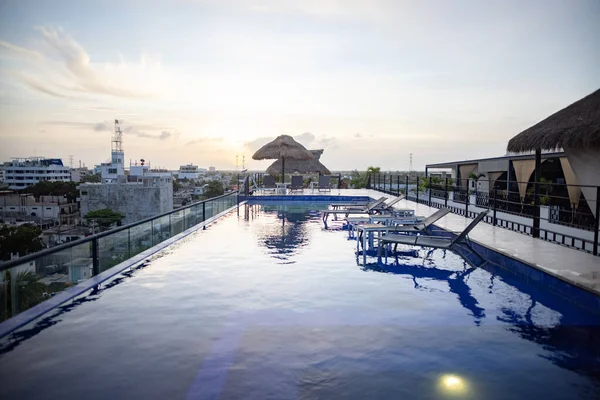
(507, 89), (600, 152)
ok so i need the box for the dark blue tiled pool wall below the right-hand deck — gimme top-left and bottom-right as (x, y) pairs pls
(427, 226), (600, 315)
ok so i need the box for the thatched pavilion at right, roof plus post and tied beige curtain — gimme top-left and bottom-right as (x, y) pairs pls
(507, 89), (600, 217)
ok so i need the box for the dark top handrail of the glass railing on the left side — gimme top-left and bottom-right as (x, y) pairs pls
(0, 192), (236, 271)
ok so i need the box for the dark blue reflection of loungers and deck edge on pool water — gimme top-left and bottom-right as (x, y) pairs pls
(363, 250), (600, 383)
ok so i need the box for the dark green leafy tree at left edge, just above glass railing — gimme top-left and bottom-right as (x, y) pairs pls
(0, 224), (44, 260)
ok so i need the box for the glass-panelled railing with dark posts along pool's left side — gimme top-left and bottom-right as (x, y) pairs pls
(0, 192), (238, 321)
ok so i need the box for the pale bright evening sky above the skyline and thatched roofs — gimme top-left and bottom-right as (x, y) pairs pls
(0, 0), (600, 171)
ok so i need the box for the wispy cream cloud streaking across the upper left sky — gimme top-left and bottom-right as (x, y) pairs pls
(0, 27), (165, 99)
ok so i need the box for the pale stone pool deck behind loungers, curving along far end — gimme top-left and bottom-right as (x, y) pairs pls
(247, 189), (600, 296)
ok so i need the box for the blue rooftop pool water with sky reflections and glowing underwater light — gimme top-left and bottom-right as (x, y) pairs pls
(0, 204), (600, 399)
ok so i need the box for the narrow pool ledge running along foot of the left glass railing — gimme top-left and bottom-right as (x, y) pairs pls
(0, 202), (243, 339)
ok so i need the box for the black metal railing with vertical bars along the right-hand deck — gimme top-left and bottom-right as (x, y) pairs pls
(367, 174), (600, 255)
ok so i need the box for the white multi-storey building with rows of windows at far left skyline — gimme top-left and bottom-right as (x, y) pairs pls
(4, 157), (71, 190)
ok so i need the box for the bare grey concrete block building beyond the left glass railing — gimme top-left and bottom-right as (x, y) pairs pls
(79, 174), (173, 224)
